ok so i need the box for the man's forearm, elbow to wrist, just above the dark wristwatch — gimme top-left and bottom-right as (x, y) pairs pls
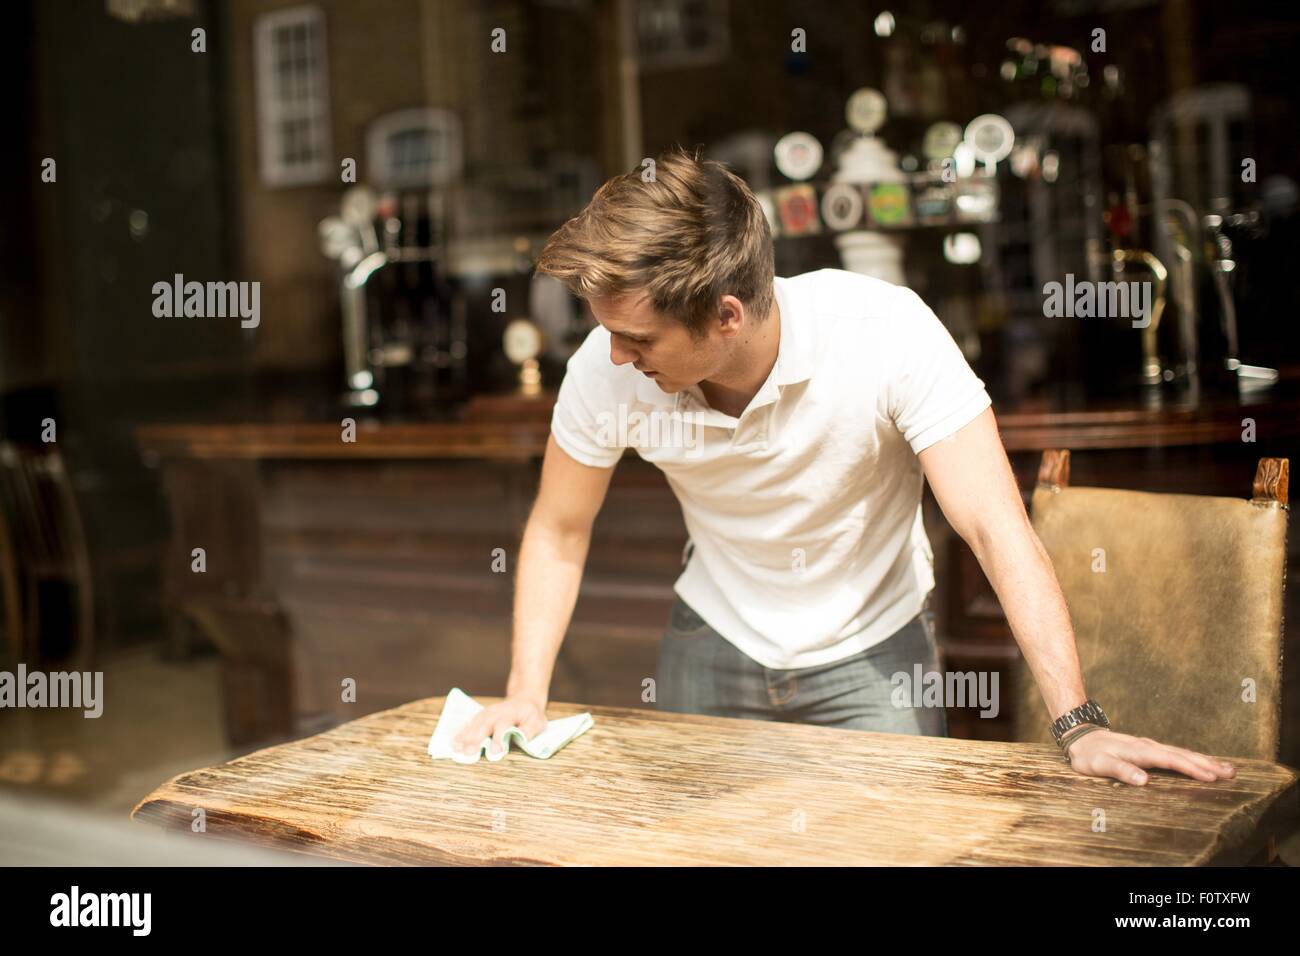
(969, 518), (1087, 718)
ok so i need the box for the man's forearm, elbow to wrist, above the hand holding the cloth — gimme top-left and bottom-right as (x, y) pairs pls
(506, 518), (592, 701)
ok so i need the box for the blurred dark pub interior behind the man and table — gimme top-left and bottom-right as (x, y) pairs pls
(0, 0), (1300, 858)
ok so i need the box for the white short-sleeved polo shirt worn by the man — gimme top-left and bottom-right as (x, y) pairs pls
(551, 269), (991, 669)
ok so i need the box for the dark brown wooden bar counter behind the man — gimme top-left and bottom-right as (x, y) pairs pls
(139, 398), (1300, 765)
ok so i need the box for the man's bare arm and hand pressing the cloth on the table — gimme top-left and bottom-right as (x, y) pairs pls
(455, 437), (616, 753)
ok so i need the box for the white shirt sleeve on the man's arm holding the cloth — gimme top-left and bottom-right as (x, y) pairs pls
(551, 326), (627, 468)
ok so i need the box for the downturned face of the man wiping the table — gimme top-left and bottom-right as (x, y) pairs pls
(588, 293), (735, 394)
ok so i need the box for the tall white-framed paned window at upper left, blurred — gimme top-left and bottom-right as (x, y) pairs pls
(254, 7), (334, 186)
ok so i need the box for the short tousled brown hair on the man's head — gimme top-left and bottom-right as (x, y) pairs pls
(537, 146), (775, 337)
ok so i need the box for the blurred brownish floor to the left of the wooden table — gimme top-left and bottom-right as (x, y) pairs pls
(0, 646), (1300, 866)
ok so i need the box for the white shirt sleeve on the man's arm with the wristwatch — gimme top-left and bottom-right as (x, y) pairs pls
(888, 289), (993, 454)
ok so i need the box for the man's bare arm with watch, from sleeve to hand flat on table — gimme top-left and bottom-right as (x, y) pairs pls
(918, 408), (1235, 784)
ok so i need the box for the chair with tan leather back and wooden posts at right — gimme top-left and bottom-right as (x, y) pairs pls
(1013, 450), (1290, 760)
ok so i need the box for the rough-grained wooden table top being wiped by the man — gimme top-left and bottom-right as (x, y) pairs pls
(131, 697), (1300, 865)
